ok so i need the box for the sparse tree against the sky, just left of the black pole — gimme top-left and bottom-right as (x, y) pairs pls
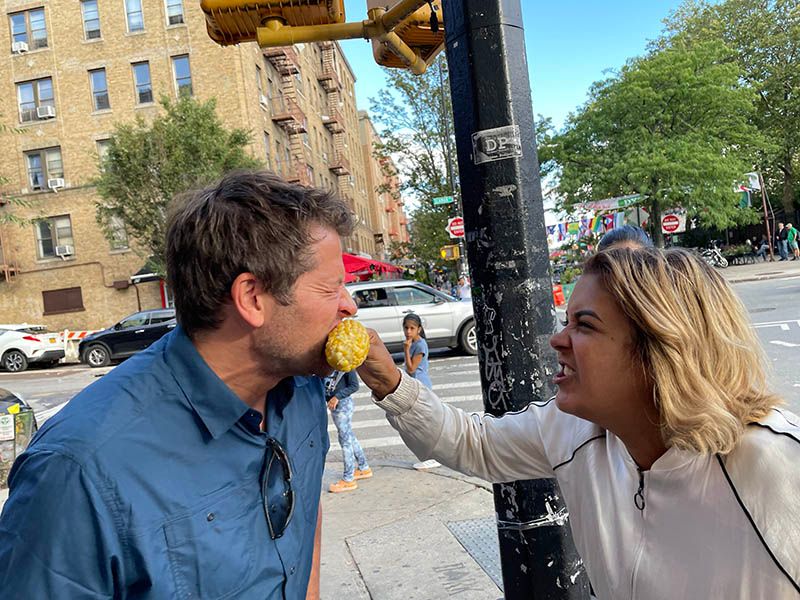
(370, 56), (459, 269)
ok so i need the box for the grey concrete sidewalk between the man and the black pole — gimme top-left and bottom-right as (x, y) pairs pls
(321, 461), (503, 600)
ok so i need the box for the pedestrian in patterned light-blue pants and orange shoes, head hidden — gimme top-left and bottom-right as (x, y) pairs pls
(325, 371), (372, 494)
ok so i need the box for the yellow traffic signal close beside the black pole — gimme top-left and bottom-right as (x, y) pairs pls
(367, 0), (444, 69)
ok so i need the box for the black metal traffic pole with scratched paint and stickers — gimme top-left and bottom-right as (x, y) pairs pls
(443, 0), (589, 600)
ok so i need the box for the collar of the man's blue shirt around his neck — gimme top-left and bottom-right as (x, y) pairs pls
(164, 325), (308, 439)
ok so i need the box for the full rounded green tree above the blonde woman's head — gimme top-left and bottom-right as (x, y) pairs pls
(550, 42), (763, 245)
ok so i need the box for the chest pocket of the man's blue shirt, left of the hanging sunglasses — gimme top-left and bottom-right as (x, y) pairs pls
(164, 485), (263, 600)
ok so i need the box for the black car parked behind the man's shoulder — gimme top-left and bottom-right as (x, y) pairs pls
(78, 308), (177, 367)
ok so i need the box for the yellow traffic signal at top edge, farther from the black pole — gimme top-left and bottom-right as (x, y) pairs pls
(200, 0), (344, 46)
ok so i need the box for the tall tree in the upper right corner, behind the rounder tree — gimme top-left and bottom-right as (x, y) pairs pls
(658, 0), (800, 214)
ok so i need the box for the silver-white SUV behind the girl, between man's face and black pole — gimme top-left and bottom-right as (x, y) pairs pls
(347, 279), (478, 355)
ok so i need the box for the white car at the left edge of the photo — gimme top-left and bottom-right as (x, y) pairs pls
(0, 323), (64, 373)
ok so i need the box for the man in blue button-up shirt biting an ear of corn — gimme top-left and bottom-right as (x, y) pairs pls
(0, 172), (355, 600)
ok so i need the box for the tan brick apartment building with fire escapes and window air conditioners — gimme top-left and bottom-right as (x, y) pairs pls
(0, 0), (408, 330)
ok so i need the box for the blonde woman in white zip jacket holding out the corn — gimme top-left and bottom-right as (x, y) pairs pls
(359, 248), (800, 600)
